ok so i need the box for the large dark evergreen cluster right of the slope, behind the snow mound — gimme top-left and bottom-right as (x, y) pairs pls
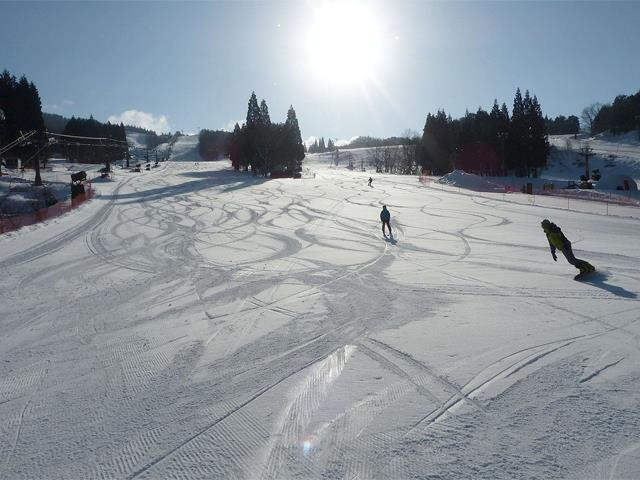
(417, 88), (550, 177)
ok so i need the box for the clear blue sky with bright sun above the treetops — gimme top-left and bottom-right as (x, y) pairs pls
(0, 0), (640, 139)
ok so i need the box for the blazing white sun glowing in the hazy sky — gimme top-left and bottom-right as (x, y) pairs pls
(307, 3), (380, 83)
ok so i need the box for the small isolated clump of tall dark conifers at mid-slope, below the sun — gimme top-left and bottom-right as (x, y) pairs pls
(229, 92), (305, 177)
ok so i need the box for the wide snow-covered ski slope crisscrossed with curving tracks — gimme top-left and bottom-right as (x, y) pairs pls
(0, 148), (640, 479)
